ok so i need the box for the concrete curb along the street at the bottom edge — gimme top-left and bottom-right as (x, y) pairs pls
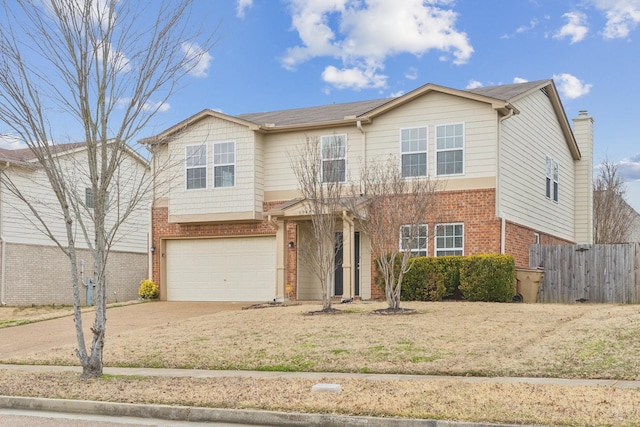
(0, 396), (544, 427)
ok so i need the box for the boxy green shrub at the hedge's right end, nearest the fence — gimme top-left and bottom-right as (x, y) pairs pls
(460, 255), (515, 302)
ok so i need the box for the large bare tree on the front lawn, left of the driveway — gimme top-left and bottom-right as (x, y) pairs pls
(0, 0), (215, 378)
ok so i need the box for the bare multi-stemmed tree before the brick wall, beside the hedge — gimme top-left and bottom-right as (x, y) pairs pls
(348, 156), (438, 310)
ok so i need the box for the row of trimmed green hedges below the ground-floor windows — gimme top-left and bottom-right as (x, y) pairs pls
(375, 254), (515, 302)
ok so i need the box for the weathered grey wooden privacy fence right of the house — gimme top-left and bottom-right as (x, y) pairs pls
(529, 243), (640, 304)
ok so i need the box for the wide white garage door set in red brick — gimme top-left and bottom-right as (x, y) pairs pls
(165, 236), (276, 301)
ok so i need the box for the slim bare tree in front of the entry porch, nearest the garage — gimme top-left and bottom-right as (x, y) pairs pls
(290, 135), (346, 311)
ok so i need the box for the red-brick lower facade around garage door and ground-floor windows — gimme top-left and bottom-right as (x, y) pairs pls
(153, 189), (571, 299)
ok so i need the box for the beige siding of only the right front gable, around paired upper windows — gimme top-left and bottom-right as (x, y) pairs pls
(364, 92), (497, 181)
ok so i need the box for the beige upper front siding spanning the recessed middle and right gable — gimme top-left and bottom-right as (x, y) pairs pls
(264, 93), (497, 192)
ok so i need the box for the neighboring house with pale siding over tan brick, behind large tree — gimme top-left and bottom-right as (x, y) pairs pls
(0, 143), (150, 306)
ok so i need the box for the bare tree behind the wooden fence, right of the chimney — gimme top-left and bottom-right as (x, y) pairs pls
(593, 159), (635, 244)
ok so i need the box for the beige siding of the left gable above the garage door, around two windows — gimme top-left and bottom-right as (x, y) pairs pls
(169, 117), (263, 216)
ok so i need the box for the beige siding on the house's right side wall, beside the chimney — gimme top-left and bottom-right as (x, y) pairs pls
(498, 91), (574, 240)
